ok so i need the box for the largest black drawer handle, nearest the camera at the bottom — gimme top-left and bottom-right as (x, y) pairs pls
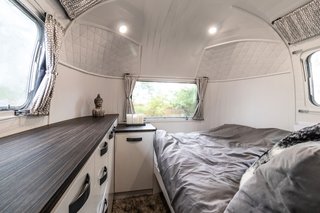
(69, 174), (90, 213)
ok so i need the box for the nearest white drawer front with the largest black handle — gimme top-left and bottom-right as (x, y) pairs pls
(52, 158), (95, 213)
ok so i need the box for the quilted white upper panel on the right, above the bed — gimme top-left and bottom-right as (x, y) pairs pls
(198, 41), (291, 81)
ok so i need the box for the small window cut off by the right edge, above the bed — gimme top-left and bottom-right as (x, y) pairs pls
(307, 51), (320, 106)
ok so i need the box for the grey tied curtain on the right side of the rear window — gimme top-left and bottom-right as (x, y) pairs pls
(192, 77), (208, 120)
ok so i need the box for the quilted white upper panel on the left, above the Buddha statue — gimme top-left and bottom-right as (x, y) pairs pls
(61, 23), (141, 77)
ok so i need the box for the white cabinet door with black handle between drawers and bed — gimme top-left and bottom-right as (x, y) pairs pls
(115, 132), (154, 192)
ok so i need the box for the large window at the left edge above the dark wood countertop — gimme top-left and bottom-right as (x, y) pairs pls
(0, 0), (43, 110)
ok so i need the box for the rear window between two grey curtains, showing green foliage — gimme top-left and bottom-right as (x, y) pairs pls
(132, 81), (197, 118)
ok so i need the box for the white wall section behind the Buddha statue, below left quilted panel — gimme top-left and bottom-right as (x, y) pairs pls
(50, 64), (124, 123)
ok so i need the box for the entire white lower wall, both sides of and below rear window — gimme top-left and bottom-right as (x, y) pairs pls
(0, 64), (295, 137)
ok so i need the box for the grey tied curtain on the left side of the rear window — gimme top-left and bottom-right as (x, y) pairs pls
(123, 75), (137, 120)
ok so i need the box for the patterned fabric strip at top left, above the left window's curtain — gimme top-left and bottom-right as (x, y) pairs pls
(60, 0), (102, 19)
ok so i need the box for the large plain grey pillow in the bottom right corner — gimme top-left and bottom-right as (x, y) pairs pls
(225, 142), (320, 213)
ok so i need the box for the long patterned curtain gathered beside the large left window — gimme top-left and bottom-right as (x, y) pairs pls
(28, 14), (64, 115)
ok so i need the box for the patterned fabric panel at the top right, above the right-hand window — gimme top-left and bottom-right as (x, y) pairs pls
(272, 0), (320, 44)
